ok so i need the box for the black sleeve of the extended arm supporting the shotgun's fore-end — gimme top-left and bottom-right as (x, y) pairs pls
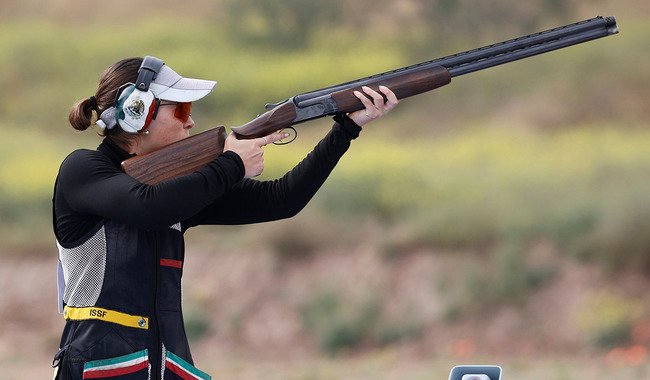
(183, 115), (361, 229)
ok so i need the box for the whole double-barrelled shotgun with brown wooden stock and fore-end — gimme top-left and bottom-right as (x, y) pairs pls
(122, 16), (618, 184)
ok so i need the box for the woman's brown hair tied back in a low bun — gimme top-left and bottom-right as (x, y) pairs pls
(68, 58), (142, 149)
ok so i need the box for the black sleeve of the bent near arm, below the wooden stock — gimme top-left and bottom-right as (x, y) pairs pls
(57, 150), (244, 229)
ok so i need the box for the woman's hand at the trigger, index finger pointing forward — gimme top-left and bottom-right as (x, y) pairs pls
(223, 131), (289, 178)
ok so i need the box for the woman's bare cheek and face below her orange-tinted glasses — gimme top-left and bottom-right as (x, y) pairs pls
(136, 101), (194, 154)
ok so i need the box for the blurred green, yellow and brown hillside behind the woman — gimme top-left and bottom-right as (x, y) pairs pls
(0, 0), (650, 379)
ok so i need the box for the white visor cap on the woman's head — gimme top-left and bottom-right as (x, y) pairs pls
(149, 65), (217, 102)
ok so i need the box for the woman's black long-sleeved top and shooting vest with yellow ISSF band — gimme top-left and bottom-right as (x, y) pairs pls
(53, 116), (361, 379)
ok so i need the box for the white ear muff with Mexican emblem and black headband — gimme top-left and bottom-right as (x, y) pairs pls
(115, 56), (165, 133)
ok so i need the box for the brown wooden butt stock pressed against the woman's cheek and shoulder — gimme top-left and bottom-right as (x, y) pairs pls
(122, 126), (226, 185)
